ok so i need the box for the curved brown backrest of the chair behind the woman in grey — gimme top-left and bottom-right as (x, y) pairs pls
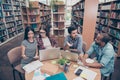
(7, 46), (22, 64)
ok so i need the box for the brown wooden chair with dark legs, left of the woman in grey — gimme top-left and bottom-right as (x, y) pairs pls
(7, 47), (24, 80)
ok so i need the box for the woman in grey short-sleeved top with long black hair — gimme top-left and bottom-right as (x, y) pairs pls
(21, 26), (39, 67)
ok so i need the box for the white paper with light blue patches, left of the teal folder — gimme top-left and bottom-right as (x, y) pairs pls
(32, 69), (49, 80)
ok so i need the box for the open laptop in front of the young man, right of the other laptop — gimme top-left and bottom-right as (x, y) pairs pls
(61, 50), (79, 61)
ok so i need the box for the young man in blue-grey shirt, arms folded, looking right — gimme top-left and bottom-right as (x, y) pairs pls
(64, 26), (83, 60)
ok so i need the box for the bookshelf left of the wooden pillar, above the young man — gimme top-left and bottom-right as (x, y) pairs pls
(71, 0), (85, 33)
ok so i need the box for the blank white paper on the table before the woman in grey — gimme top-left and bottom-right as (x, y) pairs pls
(23, 60), (43, 73)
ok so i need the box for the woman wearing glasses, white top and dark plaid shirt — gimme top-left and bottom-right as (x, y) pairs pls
(37, 28), (57, 50)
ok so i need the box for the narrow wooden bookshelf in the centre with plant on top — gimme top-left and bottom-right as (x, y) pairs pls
(52, 2), (65, 47)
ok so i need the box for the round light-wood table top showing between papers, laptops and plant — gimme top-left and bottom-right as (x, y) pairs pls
(25, 60), (101, 80)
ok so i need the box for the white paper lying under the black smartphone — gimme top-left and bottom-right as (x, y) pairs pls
(74, 66), (97, 80)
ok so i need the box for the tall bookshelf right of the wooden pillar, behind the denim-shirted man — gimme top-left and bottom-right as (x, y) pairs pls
(96, 0), (120, 55)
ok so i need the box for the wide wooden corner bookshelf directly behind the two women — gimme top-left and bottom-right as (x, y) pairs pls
(22, 1), (51, 32)
